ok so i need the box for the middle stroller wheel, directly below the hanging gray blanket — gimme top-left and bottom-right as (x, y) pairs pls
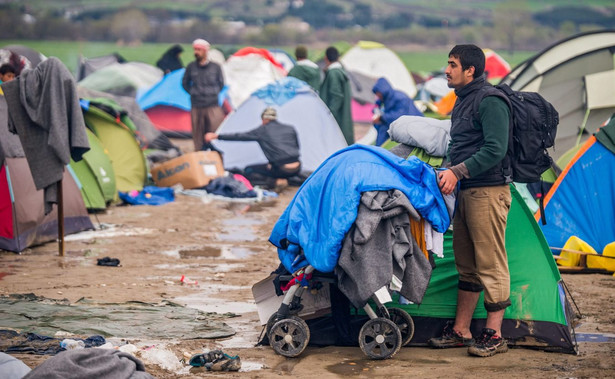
(359, 317), (402, 359)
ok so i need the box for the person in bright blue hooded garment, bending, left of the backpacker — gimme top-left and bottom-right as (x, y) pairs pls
(372, 78), (423, 146)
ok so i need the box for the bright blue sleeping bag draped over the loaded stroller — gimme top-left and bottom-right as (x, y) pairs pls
(269, 145), (450, 272)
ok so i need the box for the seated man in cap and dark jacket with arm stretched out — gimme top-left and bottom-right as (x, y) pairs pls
(205, 107), (301, 180)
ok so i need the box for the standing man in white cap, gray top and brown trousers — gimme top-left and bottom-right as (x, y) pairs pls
(182, 38), (225, 151)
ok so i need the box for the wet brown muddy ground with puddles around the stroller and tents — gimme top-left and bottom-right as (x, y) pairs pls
(0, 134), (615, 378)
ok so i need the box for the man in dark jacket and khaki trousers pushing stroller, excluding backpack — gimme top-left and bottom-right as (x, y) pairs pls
(429, 45), (511, 357)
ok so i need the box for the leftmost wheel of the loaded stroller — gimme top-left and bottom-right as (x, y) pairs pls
(268, 316), (310, 358)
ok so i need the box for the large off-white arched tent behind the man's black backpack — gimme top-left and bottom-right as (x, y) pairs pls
(502, 30), (615, 158)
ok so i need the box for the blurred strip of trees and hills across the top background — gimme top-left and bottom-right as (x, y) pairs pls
(0, 0), (615, 53)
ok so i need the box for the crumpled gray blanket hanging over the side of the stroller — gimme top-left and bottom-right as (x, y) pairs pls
(335, 190), (432, 308)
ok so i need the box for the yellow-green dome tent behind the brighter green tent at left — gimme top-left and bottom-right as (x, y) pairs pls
(81, 99), (148, 192)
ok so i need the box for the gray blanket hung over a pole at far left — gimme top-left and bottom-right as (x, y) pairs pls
(2, 57), (90, 214)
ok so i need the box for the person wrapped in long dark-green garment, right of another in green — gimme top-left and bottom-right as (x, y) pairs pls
(320, 46), (354, 145)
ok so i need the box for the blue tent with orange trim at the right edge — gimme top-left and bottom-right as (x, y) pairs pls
(536, 117), (615, 253)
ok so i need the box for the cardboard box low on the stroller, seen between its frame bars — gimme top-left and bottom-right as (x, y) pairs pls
(252, 274), (331, 325)
